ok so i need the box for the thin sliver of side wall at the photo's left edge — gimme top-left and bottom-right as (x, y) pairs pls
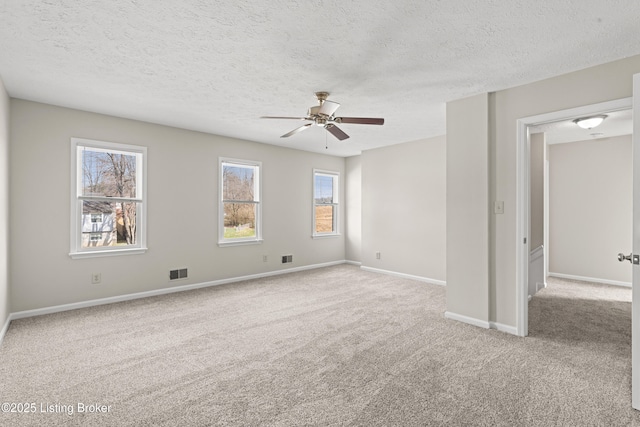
(0, 79), (11, 334)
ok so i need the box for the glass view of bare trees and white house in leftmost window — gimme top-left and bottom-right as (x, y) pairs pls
(80, 147), (137, 247)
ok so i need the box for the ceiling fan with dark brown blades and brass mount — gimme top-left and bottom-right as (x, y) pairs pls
(261, 92), (384, 141)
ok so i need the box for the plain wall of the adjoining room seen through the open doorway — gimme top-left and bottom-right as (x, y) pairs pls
(549, 135), (633, 284)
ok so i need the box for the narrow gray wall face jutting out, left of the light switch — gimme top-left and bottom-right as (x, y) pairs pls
(446, 94), (492, 322)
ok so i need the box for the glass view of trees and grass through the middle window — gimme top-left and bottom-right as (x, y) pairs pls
(222, 163), (258, 239)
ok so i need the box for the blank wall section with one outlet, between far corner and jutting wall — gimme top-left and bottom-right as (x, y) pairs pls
(361, 136), (447, 283)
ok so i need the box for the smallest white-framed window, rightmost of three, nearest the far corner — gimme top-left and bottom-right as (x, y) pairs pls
(313, 169), (340, 237)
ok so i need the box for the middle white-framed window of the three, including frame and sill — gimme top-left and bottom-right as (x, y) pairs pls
(218, 158), (262, 246)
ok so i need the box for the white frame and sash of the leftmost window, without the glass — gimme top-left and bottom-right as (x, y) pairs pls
(69, 138), (147, 259)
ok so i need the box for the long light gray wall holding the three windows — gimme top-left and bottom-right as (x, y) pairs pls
(8, 99), (345, 312)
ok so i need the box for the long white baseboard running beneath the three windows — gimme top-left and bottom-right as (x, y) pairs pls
(6, 260), (346, 322)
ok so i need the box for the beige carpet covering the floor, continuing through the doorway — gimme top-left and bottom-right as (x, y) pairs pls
(0, 265), (640, 426)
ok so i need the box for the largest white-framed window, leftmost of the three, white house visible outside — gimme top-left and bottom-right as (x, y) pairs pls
(70, 138), (147, 258)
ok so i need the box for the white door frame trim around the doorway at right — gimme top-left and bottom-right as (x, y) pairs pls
(516, 97), (633, 337)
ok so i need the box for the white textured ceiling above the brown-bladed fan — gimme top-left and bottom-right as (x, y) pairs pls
(0, 0), (640, 156)
